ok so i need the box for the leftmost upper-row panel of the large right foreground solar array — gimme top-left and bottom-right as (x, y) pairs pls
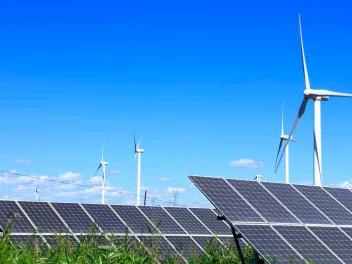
(188, 176), (264, 222)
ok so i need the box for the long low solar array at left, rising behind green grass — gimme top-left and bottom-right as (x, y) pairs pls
(0, 200), (236, 260)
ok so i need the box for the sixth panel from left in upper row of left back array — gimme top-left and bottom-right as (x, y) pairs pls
(139, 206), (186, 234)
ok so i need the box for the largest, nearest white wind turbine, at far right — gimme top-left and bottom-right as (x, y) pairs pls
(275, 15), (352, 186)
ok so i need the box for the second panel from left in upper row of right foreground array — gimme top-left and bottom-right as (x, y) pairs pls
(227, 179), (299, 223)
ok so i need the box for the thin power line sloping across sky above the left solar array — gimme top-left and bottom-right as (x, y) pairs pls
(0, 170), (186, 207)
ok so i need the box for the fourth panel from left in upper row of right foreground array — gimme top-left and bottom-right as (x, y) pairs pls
(294, 185), (352, 225)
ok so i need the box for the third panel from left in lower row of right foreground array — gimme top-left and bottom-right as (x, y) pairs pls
(309, 227), (352, 263)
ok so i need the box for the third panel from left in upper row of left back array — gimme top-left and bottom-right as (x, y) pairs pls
(51, 203), (96, 233)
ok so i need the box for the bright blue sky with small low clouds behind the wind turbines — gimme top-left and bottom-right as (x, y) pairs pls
(0, 1), (352, 206)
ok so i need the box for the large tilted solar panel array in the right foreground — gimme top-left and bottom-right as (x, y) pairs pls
(188, 176), (352, 263)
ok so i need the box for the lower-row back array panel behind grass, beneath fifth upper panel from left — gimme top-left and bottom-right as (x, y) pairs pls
(138, 236), (178, 260)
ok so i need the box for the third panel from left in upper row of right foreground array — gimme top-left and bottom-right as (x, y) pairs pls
(261, 182), (332, 224)
